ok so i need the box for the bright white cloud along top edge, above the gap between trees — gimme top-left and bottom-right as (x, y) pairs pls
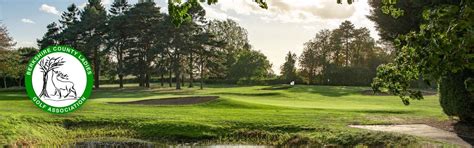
(211, 0), (356, 23)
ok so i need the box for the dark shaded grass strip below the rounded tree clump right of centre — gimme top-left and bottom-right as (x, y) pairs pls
(288, 86), (360, 97)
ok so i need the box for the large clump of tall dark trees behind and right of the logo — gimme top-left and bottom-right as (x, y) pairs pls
(38, 0), (271, 89)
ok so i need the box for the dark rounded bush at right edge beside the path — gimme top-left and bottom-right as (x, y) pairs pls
(439, 72), (474, 123)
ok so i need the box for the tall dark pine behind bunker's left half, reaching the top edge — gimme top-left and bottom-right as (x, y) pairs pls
(125, 2), (168, 87)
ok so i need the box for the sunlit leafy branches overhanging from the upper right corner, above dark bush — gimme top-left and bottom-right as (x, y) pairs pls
(373, 0), (474, 104)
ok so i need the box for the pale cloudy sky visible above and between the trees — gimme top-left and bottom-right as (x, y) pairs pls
(0, 0), (379, 74)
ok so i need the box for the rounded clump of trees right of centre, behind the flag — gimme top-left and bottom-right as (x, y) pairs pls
(281, 21), (391, 85)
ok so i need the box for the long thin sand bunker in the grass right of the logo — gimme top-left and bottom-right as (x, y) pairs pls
(109, 96), (219, 105)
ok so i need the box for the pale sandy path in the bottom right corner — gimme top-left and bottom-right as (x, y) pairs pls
(349, 124), (472, 147)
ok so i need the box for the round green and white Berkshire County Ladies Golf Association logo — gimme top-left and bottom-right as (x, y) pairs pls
(25, 46), (93, 114)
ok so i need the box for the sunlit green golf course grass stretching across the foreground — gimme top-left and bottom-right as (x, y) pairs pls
(0, 85), (447, 145)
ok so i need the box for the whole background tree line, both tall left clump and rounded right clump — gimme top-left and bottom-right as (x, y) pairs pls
(4, 0), (391, 89)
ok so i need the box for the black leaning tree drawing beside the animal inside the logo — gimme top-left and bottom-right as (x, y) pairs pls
(39, 57), (65, 98)
